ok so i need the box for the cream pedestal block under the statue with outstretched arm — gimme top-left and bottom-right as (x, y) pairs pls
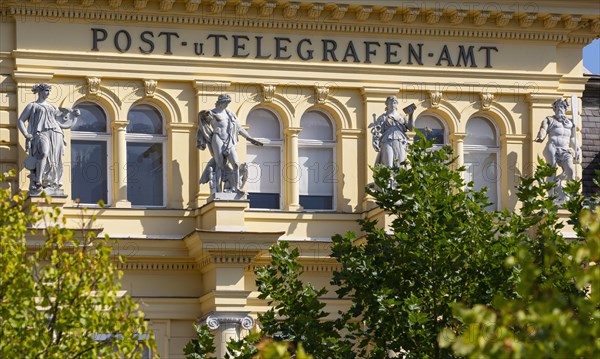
(198, 193), (250, 231)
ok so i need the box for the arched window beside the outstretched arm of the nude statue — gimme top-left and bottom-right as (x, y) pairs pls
(246, 108), (283, 209)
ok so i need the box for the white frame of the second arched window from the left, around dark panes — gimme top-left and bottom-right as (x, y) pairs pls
(125, 102), (169, 208)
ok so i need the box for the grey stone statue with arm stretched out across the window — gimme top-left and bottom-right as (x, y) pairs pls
(196, 95), (263, 193)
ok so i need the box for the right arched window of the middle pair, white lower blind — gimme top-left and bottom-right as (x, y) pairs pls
(298, 111), (336, 210)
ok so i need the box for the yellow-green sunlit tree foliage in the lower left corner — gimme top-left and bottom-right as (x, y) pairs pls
(0, 173), (154, 359)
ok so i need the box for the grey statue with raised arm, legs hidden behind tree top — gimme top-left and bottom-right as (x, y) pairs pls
(369, 96), (416, 167)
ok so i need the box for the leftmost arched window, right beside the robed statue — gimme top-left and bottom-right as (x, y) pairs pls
(71, 102), (111, 204)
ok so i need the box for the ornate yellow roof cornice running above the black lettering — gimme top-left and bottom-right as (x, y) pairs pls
(0, 0), (600, 44)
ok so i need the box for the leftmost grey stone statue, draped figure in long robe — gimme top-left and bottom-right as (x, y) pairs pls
(18, 84), (80, 196)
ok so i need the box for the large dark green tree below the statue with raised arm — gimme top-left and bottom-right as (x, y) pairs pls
(333, 136), (515, 358)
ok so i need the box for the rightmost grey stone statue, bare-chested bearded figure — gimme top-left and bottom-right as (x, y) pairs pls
(535, 99), (581, 203)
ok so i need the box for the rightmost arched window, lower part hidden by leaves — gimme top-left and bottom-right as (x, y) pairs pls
(464, 117), (501, 210)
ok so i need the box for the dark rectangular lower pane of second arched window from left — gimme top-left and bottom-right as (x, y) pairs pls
(127, 142), (164, 206)
